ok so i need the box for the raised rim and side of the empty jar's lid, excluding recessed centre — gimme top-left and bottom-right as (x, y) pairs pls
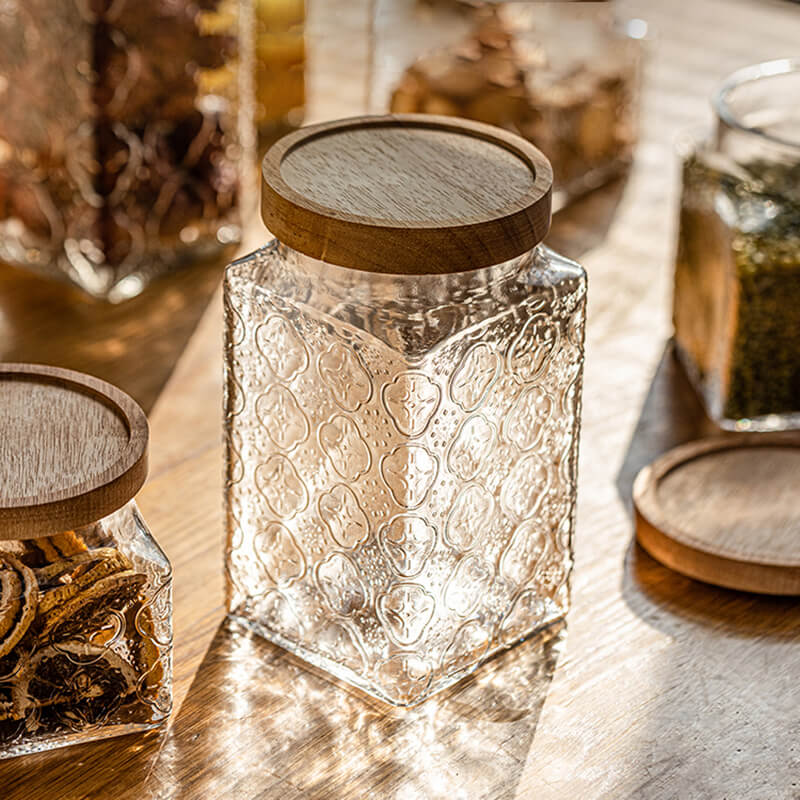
(261, 114), (553, 275)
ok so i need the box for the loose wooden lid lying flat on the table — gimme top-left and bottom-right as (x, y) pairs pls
(633, 433), (800, 595)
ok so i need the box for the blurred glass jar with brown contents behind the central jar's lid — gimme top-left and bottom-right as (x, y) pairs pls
(370, 0), (646, 210)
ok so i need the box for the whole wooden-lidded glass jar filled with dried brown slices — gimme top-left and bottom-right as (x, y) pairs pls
(0, 364), (172, 759)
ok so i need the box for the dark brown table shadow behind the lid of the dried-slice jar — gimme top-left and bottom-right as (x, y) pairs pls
(0, 250), (231, 412)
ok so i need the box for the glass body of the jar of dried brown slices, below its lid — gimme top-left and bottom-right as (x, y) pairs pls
(0, 501), (172, 758)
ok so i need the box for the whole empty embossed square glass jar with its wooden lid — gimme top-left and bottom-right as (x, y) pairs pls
(225, 115), (586, 705)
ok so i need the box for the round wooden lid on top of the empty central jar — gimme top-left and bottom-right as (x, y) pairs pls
(261, 114), (553, 275)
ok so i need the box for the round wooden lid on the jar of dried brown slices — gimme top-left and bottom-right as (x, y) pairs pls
(0, 364), (148, 540)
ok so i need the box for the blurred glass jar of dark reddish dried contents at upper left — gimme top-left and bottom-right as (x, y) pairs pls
(0, 0), (240, 301)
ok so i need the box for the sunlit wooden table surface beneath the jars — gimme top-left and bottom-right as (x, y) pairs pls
(0, 0), (800, 800)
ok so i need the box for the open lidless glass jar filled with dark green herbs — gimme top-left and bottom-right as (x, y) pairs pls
(673, 61), (800, 430)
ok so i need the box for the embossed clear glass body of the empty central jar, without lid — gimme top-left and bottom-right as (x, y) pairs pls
(225, 242), (586, 705)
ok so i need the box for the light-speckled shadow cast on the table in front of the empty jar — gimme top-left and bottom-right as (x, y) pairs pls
(137, 622), (565, 800)
